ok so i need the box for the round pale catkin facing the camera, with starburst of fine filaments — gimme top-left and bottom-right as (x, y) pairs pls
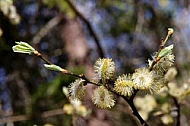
(132, 67), (154, 90)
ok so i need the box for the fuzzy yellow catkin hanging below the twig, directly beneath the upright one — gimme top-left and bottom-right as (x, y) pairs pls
(92, 86), (115, 108)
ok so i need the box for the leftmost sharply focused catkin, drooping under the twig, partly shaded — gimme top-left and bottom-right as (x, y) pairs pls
(68, 79), (86, 100)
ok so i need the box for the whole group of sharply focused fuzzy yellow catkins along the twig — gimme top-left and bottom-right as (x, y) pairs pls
(69, 45), (174, 108)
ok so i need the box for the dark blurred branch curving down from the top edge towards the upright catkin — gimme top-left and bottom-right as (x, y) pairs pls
(65, 0), (105, 58)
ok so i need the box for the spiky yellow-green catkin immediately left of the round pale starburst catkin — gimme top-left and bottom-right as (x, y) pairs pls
(113, 75), (137, 97)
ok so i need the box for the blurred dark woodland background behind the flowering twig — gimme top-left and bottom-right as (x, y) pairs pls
(0, 0), (190, 126)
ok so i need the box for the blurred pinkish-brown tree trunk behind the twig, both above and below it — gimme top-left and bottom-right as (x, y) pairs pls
(61, 18), (110, 126)
